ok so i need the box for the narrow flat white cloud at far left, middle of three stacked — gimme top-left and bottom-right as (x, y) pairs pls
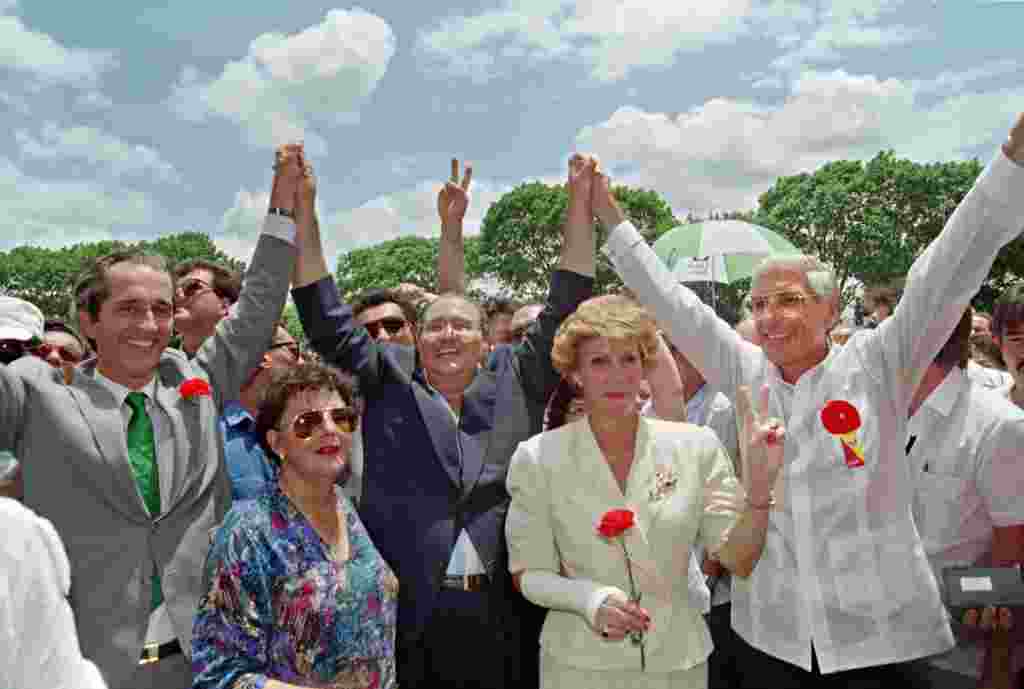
(14, 122), (181, 183)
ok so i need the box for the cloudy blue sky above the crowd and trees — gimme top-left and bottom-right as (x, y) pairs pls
(0, 0), (1024, 262)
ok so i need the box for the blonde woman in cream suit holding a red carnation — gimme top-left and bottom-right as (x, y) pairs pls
(506, 296), (783, 689)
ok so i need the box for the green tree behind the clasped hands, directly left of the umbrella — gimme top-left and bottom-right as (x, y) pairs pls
(479, 182), (679, 299)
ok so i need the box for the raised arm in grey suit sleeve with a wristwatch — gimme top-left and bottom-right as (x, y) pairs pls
(196, 144), (302, 403)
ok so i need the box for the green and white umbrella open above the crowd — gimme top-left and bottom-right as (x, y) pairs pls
(653, 220), (800, 285)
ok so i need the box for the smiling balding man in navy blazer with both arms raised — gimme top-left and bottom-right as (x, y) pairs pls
(292, 156), (595, 689)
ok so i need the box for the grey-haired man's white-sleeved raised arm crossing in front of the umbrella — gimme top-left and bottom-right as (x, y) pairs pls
(593, 174), (763, 409)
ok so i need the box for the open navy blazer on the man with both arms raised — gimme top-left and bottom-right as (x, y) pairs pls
(293, 270), (593, 639)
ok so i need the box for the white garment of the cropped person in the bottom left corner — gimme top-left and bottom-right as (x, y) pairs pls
(0, 498), (106, 689)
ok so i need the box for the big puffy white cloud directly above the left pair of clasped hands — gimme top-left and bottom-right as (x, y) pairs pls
(171, 8), (395, 155)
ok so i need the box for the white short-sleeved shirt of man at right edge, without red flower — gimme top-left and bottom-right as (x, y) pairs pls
(907, 369), (1024, 677)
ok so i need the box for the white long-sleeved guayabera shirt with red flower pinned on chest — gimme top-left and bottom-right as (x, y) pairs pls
(604, 153), (1024, 673)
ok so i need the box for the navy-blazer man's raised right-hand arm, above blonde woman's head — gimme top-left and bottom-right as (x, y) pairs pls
(516, 154), (597, 404)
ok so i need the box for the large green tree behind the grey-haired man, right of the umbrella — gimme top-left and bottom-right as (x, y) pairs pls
(755, 150), (1024, 305)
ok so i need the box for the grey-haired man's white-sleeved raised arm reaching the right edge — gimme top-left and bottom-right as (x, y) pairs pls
(867, 115), (1024, 407)
